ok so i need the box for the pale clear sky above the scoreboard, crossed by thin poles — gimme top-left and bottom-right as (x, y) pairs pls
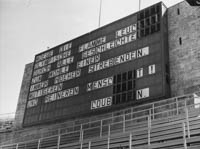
(0, 0), (182, 117)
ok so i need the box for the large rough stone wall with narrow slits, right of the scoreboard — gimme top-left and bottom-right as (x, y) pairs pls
(168, 1), (200, 96)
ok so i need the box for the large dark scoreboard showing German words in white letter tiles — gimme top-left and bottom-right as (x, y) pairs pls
(23, 3), (170, 126)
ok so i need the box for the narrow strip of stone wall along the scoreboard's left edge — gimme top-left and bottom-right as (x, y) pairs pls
(14, 63), (33, 129)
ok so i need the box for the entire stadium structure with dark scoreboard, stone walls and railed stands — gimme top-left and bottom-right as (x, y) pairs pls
(0, 1), (200, 149)
